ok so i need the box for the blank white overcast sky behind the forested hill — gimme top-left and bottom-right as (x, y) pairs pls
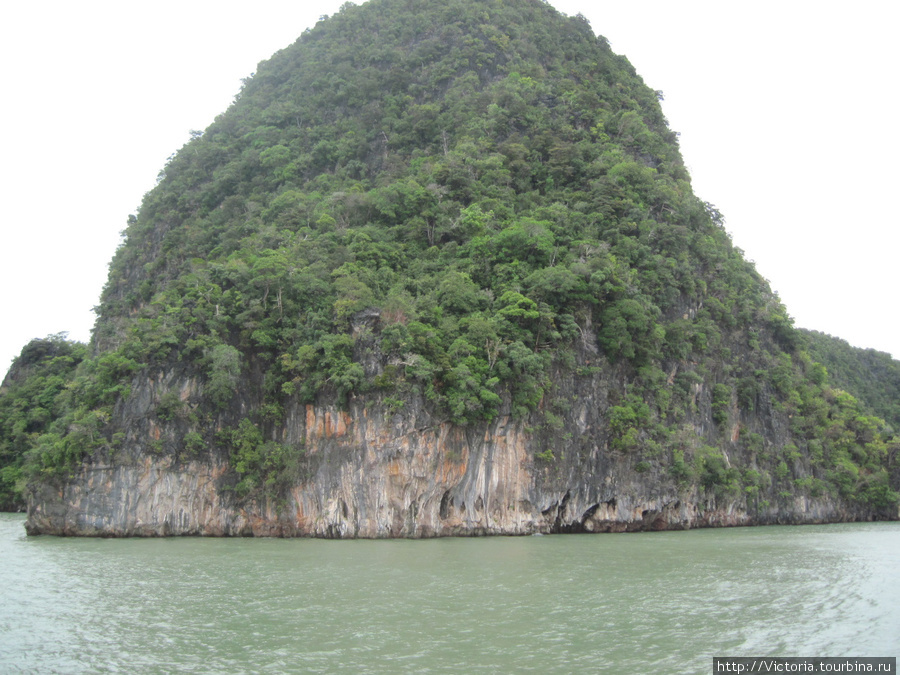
(0, 0), (900, 372)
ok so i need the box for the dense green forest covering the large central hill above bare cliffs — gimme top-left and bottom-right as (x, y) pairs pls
(0, 0), (896, 507)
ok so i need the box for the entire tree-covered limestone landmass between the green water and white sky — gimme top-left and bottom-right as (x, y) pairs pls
(0, 0), (900, 537)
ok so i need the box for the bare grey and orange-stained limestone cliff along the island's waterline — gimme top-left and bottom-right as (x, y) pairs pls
(26, 352), (884, 538)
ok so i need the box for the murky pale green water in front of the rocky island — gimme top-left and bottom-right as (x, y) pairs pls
(0, 514), (900, 673)
